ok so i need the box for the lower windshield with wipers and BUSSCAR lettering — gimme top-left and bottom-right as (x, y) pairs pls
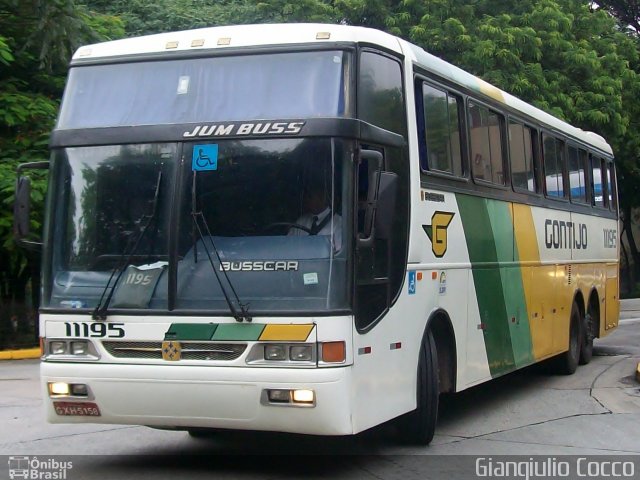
(44, 138), (352, 314)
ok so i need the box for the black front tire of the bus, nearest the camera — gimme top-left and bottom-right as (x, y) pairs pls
(401, 330), (440, 445)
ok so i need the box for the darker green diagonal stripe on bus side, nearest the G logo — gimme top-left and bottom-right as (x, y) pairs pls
(456, 195), (515, 377)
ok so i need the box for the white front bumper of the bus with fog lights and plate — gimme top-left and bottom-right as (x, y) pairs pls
(40, 362), (356, 435)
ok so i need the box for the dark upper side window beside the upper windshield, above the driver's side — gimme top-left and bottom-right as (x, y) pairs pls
(358, 52), (407, 135)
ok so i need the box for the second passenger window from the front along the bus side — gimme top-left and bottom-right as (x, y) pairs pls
(469, 102), (504, 185)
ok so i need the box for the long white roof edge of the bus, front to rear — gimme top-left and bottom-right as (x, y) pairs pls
(73, 23), (613, 155)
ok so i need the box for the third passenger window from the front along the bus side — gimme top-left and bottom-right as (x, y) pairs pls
(509, 120), (538, 192)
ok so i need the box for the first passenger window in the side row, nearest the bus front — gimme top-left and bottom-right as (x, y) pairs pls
(421, 83), (463, 177)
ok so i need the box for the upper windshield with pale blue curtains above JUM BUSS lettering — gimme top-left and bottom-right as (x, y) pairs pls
(57, 51), (348, 129)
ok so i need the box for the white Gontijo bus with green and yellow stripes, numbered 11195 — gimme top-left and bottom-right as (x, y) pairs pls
(21, 24), (618, 444)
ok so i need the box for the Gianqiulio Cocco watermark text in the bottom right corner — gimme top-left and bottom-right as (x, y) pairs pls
(476, 457), (636, 480)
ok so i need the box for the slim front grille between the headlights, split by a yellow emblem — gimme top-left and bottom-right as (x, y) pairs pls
(102, 341), (247, 361)
